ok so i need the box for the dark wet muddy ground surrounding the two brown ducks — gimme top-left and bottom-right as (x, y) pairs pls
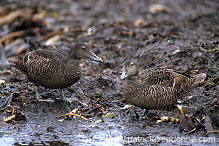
(0, 0), (219, 145)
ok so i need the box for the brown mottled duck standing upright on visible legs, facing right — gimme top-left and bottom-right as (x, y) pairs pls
(8, 44), (103, 100)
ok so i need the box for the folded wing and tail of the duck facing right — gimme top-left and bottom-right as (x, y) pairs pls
(9, 49), (64, 82)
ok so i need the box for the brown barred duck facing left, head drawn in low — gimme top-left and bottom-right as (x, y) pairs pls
(121, 60), (206, 109)
